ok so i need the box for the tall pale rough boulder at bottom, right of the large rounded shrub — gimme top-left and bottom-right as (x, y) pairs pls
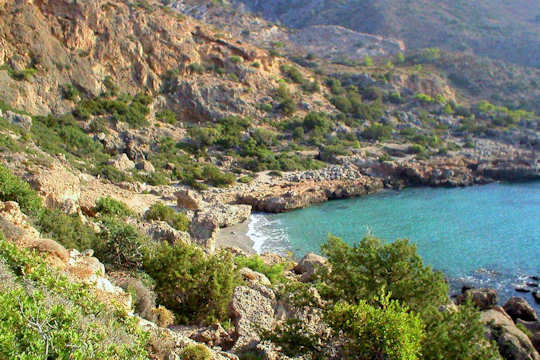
(231, 286), (276, 352)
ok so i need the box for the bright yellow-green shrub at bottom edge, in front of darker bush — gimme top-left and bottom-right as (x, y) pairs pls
(329, 296), (425, 360)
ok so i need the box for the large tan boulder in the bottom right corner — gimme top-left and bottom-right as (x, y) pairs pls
(480, 306), (540, 360)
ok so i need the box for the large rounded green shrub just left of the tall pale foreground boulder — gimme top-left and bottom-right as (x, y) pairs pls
(144, 243), (243, 324)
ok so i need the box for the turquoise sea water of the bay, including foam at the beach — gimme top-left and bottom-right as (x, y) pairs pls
(248, 182), (540, 310)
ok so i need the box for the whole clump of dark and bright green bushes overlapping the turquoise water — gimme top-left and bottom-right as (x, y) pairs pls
(265, 237), (498, 360)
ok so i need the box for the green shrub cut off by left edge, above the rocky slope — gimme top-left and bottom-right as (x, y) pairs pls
(0, 164), (42, 214)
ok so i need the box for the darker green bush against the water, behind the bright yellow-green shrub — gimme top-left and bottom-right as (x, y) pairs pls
(322, 236), (448, 310)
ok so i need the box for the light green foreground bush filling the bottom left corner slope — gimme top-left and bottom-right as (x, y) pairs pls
(0, 233), (148, 360)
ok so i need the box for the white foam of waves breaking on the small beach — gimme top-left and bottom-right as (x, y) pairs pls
(246, 213), (288, 254)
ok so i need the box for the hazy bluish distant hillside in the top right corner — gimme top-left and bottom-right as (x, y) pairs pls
(234, 0), (540, 67)
